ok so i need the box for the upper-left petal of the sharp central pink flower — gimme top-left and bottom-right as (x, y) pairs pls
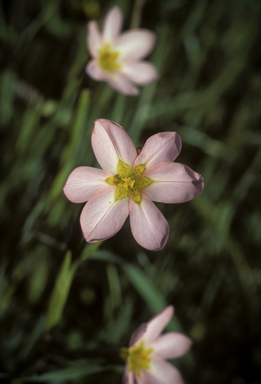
(92, 119), (137, 174)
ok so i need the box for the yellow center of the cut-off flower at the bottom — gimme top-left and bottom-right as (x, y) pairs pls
(120, 341), (152, 376)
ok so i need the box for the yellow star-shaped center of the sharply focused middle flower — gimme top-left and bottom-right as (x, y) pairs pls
(105, 160), (153, 203)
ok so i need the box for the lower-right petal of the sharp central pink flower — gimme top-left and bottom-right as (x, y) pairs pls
(130, 194), (169, 251)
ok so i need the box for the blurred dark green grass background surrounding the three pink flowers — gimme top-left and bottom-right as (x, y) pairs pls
(0, 0), (261, 384)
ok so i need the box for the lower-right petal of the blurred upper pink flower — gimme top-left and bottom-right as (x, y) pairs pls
(122, 61), (158, 85)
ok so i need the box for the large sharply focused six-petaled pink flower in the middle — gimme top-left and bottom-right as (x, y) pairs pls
(64, 119), (203, 251)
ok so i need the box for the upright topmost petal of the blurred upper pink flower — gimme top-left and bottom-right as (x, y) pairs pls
(102, 6), (123, 43)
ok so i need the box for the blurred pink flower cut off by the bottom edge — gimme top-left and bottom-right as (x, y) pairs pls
(121, 306), (191, 384)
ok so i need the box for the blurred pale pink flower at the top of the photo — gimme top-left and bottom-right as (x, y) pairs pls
(86, 6), (158, 95)
